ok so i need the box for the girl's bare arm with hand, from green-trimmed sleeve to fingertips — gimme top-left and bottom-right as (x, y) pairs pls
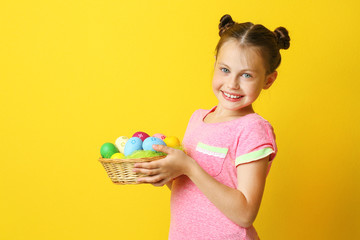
(134, 145), (269, 227)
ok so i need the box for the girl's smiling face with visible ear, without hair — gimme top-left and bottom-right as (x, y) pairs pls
(212, 40), (277, 116)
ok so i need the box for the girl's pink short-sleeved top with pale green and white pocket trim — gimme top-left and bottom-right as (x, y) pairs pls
(169, 106), (277, 240)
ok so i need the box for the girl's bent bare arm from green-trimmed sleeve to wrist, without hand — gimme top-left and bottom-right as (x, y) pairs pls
(187, 156), (269, 227)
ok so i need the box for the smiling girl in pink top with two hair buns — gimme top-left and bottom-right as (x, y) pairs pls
(134, 15), (290, 240)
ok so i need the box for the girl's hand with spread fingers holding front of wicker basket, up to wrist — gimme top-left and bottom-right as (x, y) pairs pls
(133, 145), (193, 187)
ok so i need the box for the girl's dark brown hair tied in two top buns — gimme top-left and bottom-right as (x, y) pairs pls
(215, 14), (290, 74)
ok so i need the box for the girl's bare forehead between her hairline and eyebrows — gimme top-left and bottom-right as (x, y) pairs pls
(218, 40), (265, 71)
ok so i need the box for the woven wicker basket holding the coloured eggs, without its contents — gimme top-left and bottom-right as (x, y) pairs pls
(99, 155), (166, 184)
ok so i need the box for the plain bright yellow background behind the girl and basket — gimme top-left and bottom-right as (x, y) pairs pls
(0, 0), (360, 240)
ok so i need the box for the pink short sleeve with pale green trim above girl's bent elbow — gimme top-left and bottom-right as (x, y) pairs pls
(235, 120), (277, 167)
